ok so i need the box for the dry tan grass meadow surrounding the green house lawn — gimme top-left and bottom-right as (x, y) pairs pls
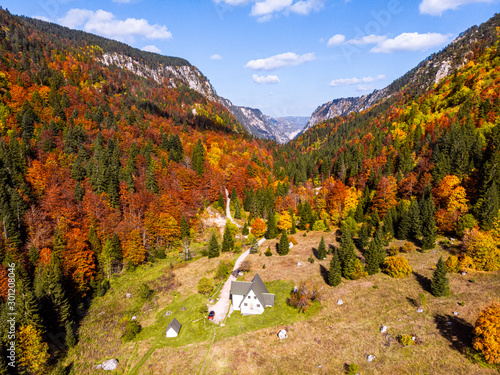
(64, 232), (500, 375)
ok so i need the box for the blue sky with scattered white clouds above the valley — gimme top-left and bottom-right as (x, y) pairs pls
(0, 0), (500, 117)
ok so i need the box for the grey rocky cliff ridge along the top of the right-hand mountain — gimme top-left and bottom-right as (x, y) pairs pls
(303, 15), (500, 132)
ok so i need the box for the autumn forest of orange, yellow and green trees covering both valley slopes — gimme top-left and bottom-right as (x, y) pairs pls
(0, 6), (500, 374)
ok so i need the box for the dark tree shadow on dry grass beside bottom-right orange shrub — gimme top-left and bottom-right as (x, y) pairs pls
(434, 315), (474, 354)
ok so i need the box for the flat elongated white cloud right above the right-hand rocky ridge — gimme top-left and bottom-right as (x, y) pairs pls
(370, 33), (451, 53)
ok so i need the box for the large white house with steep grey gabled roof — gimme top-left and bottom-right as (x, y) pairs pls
(231, 274), (274, 315)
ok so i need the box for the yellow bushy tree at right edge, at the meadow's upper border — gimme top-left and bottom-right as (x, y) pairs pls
(462, 228), (500, 271)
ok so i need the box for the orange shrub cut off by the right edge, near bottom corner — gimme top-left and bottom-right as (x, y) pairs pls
(473, 303), (500, 363)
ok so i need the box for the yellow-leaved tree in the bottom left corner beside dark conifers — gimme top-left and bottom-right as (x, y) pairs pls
(18, 324), (49, 374)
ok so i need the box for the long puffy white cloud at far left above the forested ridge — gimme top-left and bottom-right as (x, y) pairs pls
(58, 9), (172, 41)
